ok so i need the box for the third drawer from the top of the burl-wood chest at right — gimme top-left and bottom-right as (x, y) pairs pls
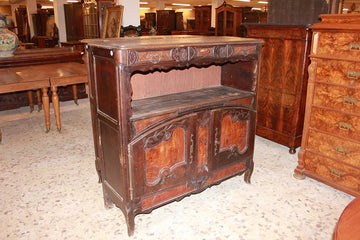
(313, 83), (360, 113)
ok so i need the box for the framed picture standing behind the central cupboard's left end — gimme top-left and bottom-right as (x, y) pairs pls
(101, 5), (124, 38)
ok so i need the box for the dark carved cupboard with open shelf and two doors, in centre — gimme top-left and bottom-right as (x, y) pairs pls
(86, 36), (261, 235)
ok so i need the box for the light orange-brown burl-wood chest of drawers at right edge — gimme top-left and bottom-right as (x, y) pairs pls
(294, 14), (360, 196)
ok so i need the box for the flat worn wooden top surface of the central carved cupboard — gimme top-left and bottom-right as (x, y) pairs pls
(83, 35), (262, 49)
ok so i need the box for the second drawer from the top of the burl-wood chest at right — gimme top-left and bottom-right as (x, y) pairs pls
(316, 59), (360, 87)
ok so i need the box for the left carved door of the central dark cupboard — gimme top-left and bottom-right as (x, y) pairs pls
(130, 114), (196, 201)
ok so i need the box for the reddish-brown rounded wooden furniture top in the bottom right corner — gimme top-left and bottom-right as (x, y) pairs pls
(333, 198), (360, 240)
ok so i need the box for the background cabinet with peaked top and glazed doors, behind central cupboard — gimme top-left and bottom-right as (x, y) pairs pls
(215, 1), (242, 37)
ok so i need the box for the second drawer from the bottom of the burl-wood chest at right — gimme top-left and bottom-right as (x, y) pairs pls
(307, 129), (360, 168)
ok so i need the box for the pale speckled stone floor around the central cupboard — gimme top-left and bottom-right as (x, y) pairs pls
(0, 99), (354, 240)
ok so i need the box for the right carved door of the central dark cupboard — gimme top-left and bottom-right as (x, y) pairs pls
(211, 107), (256, 170)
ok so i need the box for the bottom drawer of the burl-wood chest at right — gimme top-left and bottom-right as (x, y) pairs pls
(304, 152), (360, 191)
